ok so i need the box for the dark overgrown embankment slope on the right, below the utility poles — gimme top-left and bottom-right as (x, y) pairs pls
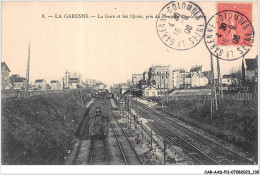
(162, 100), (258, 158)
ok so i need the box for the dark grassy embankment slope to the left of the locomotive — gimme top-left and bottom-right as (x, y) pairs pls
(1, 90), (90, 165)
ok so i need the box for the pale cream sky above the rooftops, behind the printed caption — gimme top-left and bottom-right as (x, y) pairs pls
(1, 2), (258, 85)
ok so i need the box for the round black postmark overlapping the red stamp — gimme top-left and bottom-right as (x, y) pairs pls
(204, 10), (254, 61)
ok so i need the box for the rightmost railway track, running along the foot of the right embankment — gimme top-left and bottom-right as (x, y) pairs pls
(134, 102), (254, 165)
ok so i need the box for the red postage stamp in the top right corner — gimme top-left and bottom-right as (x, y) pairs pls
(217, 3), (252, 46)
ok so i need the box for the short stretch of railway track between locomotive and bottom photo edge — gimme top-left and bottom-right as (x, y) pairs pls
(89, 138), (108, 165)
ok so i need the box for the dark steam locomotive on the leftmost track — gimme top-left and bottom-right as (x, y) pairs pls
(88, 103), (109, 139)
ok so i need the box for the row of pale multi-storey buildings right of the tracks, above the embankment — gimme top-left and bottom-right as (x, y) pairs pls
(132, 56), (258, 96)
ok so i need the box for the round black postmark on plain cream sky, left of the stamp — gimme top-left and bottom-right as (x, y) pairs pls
(156, 1), (206, 50)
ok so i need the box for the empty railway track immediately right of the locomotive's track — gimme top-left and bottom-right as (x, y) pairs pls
(107, 100), (144, 165)
